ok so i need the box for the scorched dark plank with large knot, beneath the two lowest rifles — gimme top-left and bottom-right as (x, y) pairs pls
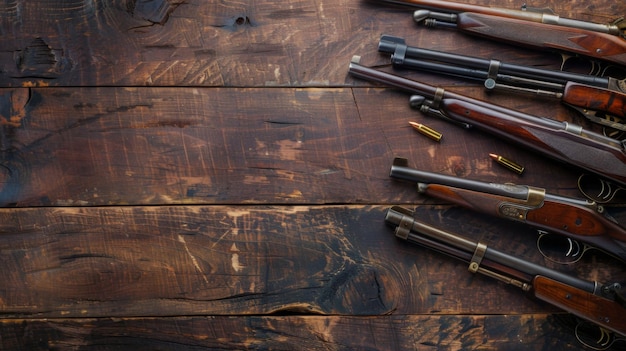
(0, 205), (626, 318)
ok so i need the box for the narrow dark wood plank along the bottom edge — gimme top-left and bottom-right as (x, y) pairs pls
(0, 314), (600, 351)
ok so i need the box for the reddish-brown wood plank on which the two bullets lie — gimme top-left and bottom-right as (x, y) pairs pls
(0, 87), (600, 206)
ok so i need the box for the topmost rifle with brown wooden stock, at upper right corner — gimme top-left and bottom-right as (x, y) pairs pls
(366, 0), (626, 66)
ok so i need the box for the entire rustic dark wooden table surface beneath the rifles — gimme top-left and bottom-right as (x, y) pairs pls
(0, 0), (626, 350)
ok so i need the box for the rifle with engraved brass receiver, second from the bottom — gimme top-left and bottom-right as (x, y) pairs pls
(389, 158), (626, 262)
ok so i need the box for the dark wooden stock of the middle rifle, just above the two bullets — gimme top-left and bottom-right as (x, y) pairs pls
(441, 99), (626, 184)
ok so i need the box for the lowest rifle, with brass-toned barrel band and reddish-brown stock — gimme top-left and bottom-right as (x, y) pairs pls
(385, 206), (626, 348)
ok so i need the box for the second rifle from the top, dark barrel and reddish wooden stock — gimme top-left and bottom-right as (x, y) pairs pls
(378, 35), (626, 131)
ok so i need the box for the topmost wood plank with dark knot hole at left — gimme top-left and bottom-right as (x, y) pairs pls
(0, 0), (626, 87)
